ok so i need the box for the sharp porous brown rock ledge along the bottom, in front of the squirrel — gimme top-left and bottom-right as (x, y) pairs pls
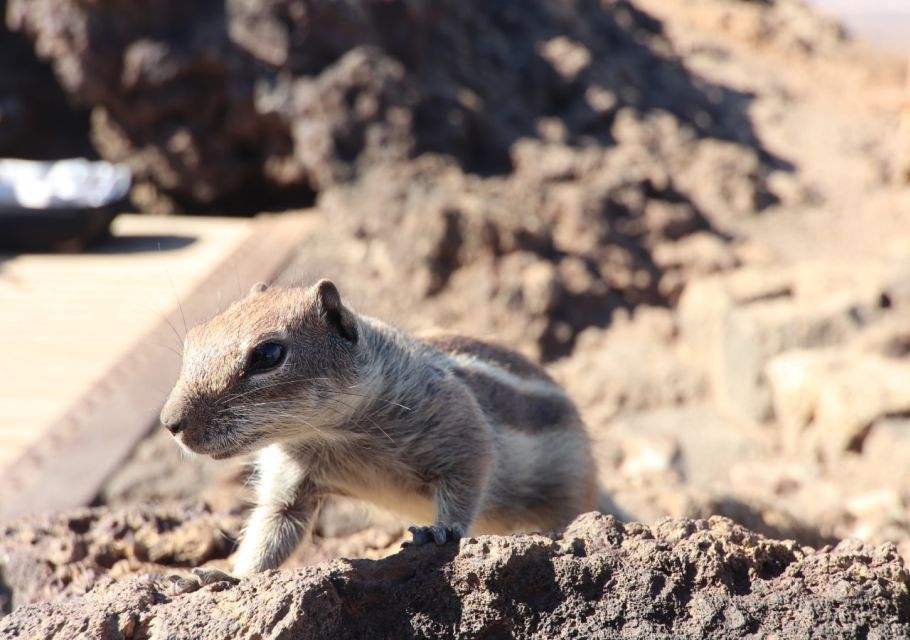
(0, 513), (910, 639)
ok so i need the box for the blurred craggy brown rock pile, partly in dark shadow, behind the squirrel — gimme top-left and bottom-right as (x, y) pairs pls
(8, 0), (787, 359)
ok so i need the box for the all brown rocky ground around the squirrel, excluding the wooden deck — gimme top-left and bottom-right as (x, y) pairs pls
(0, 0), (910, 637)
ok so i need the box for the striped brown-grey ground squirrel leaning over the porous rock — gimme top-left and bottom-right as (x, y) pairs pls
(161, 280), (597, 575)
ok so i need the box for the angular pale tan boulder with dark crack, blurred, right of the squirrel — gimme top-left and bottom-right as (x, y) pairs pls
(679, 261), (910, 421)
